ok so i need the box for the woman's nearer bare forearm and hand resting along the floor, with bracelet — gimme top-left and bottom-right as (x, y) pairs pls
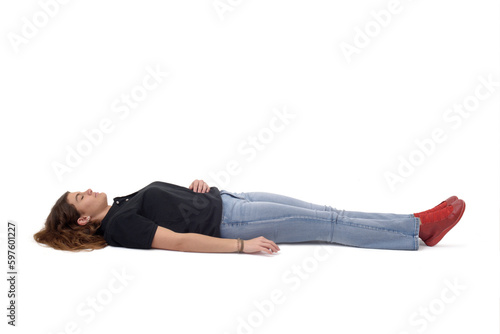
(151, 226), (280, 254)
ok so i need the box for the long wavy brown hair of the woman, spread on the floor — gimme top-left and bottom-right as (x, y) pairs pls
(33, 191), (108, 251)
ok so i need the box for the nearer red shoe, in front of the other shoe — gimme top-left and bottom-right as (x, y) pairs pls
(418, 199), (465, 247)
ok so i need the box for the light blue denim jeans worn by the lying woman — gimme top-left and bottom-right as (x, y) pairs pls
(220, 190), (420, 250)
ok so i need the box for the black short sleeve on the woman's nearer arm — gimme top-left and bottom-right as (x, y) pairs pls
(104, 213), (158, 249)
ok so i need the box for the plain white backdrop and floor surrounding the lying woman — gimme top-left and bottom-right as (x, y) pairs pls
(0, 0), (500, 334)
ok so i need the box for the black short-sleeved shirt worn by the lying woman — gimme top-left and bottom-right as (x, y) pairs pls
(97, 182), (222, 249)
